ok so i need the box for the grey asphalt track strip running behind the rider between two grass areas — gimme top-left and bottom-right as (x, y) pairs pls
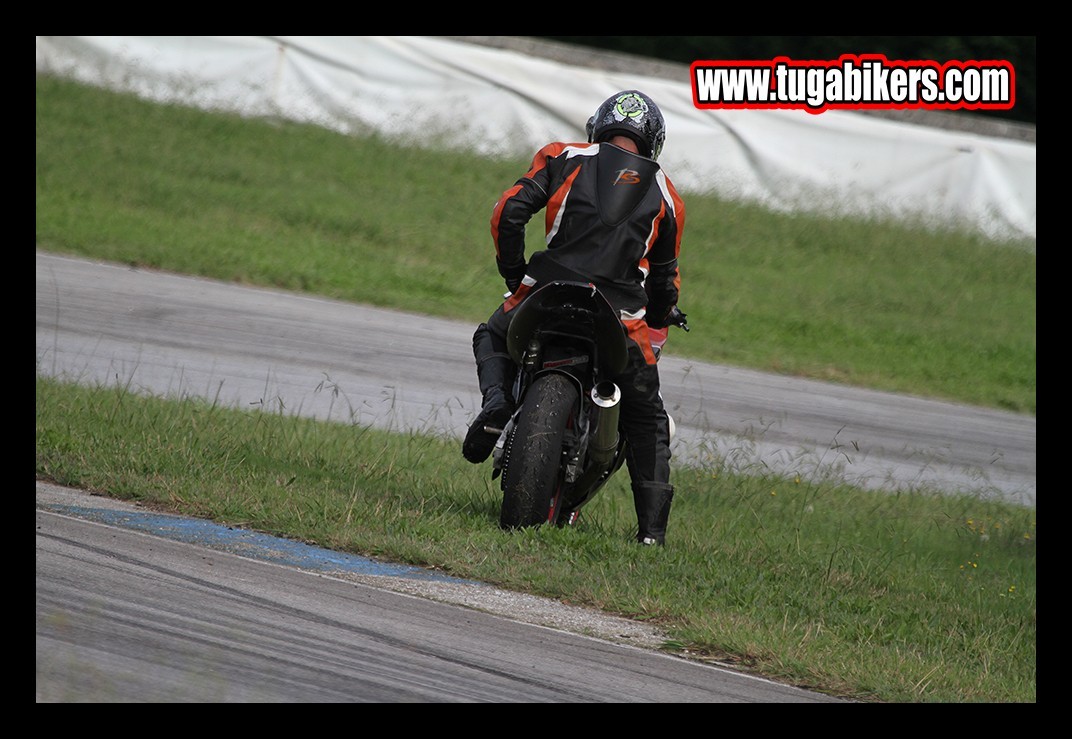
(36, 247), (1036, 506)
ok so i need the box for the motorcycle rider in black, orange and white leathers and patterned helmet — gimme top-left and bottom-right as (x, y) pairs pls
(462, 90), (685, 545)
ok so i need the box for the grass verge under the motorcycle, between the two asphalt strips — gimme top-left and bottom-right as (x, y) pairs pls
(36, 378), (1037, 703)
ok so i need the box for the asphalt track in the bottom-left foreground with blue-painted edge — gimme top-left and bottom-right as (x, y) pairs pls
(36, 483), (844, 704)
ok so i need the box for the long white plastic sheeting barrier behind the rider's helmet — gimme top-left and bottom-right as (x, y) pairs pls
(36, 36), (1036, 240)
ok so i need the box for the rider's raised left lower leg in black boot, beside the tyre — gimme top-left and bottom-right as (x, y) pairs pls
(462, 324), (517, 464)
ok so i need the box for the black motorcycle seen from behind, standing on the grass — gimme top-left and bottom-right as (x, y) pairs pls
(488, 281), (688, 529)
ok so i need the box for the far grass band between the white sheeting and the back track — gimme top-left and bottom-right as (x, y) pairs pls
(36, 76), (1036, 414)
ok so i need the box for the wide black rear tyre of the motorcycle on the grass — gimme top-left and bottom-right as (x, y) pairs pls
(498, 373), (578, 529)
